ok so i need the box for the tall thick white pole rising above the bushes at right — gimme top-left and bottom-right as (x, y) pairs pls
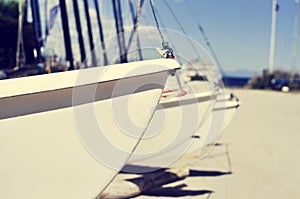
(269, 0), (278, 73)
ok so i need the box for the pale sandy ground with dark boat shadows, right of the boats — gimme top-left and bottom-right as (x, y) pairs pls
(131, 90), (300, 199)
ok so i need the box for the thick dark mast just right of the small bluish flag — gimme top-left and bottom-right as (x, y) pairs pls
(59, 0), (74, 70)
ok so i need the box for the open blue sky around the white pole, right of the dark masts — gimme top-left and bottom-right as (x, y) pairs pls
(149, 0), (300, 72)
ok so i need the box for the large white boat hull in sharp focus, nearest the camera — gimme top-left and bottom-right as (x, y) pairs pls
(0, 59), (179, 199)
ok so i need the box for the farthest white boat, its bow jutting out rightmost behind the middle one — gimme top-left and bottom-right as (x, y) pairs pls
(179, 63), (241, 158)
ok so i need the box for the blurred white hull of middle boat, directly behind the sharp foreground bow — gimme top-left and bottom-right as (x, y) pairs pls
(123, 78), (214, 173)
